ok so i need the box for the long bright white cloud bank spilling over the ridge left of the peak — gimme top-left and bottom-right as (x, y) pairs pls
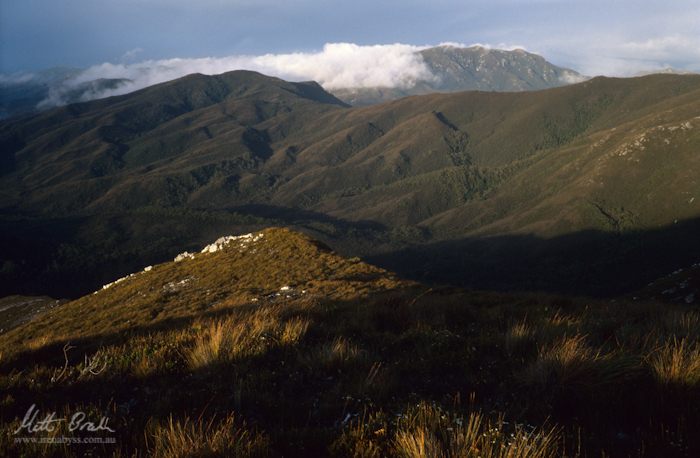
(32, 43), (436, 108)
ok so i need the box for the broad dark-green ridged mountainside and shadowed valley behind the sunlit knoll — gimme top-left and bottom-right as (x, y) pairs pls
(0, 72), (700, 294)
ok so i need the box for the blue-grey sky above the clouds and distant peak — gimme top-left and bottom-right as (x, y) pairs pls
(0, 0), (700, 75)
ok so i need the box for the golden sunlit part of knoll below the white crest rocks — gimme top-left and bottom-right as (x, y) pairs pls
(4, 229), (402, 348)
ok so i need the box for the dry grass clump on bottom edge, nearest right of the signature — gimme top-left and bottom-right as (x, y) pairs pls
(149, 415), (270, 458)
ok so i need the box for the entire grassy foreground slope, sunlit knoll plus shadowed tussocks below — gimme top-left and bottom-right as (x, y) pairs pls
(0, 229), (700, 457)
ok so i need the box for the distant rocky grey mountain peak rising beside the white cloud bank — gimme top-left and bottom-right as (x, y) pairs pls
(333, 46), (586, 105)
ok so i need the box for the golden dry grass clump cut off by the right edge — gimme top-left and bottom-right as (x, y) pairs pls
(648, 338), (700, 386)
